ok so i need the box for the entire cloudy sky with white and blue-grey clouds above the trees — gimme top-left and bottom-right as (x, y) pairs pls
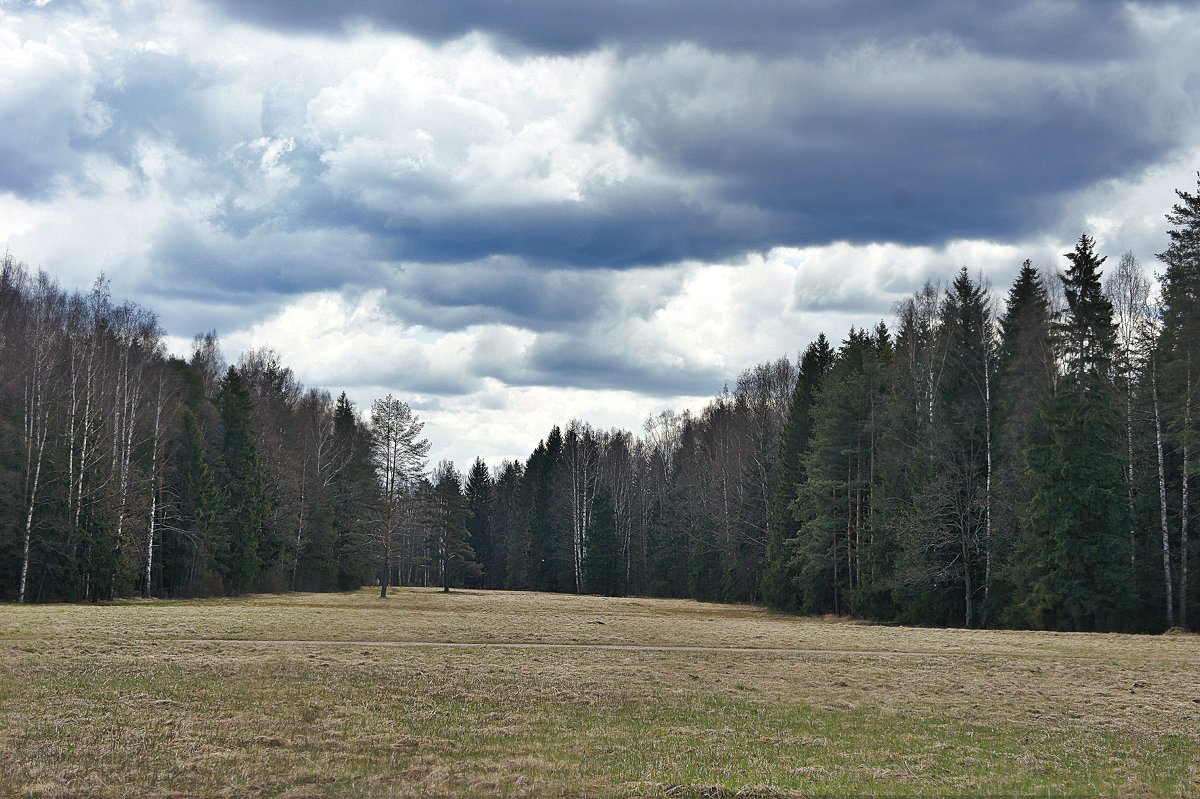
(0, 0), (1200, 468)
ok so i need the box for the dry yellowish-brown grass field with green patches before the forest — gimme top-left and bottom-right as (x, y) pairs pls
(0, 589), (1200, 797)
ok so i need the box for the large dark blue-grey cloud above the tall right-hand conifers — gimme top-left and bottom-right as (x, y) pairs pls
(612, 47), (1181, 247)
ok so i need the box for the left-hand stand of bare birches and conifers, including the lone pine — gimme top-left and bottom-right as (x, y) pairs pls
(0, 263), (478, 602)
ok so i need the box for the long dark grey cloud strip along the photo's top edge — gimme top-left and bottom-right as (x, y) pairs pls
(216, 0), (1134, 60)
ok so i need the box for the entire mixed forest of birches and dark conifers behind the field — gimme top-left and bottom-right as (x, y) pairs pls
(0, 177), (1200, 632)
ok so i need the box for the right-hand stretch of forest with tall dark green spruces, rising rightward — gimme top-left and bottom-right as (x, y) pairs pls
(453, 173), (1200, 631)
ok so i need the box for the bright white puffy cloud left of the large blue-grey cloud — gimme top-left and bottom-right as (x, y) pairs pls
(306, 36), (635, 208)
